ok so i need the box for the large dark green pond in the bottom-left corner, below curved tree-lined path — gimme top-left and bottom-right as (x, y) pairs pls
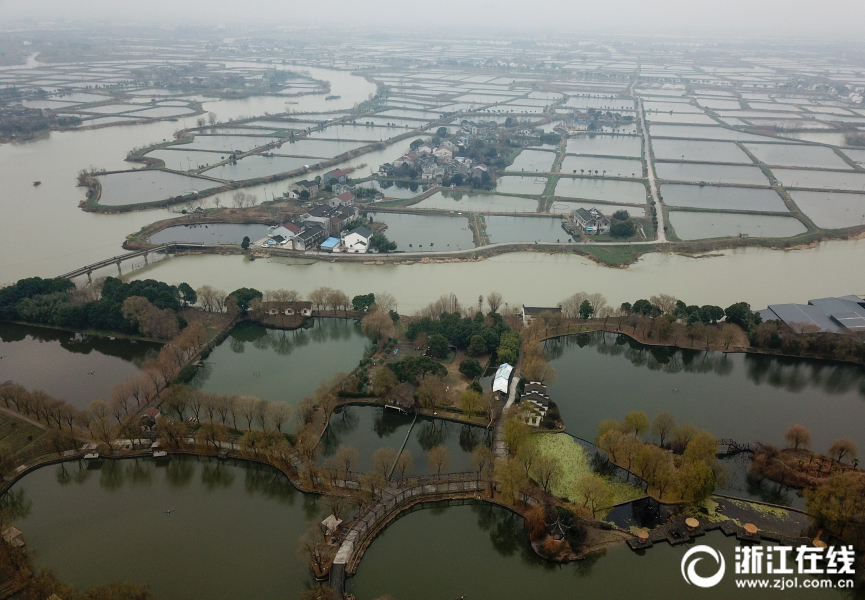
(14, 457), (325, 600)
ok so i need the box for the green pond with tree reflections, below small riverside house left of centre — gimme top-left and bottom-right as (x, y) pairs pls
(193, 319), (370, 406)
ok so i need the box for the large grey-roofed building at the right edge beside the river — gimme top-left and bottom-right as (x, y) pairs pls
(757, 295), (865, 333)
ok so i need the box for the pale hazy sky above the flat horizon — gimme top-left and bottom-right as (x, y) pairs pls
(0, 0), (865, 40)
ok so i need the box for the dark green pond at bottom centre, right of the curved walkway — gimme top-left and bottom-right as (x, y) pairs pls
(348, 503), (844, 600)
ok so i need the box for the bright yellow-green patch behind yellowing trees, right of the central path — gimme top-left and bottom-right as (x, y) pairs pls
(531, 433), (645, 516)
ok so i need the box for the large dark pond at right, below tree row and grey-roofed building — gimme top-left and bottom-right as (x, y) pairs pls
(546, 333), (865, 452)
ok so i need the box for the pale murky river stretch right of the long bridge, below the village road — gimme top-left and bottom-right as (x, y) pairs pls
(125, 240), (865, 314)
